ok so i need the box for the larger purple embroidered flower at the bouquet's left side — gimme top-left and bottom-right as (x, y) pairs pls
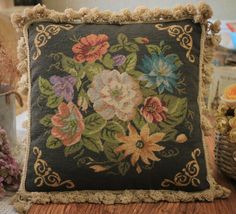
(50, 75), (76, 102)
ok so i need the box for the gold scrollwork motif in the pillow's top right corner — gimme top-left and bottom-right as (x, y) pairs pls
(155, 24), (195, 63)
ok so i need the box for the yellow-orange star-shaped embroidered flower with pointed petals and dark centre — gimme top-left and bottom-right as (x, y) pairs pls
(115, 123), (165, 166)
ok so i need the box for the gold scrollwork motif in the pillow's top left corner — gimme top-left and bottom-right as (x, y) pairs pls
(33, 24), (73, 60)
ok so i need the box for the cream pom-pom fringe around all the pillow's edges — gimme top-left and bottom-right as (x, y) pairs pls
(12, 3), (230, 213)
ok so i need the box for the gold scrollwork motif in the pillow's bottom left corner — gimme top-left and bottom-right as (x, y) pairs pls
(33, 147), (75, 189)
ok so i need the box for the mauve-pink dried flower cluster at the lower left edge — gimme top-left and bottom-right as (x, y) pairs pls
(0, 127), (21, 198)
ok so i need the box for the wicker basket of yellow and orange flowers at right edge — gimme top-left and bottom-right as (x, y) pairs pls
(215, 84), (236, 180)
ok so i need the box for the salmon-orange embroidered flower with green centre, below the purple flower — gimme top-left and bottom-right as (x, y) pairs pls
(51, 102), (84, 146)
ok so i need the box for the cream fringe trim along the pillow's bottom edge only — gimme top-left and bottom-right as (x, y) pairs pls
(13, 182), (230, 213)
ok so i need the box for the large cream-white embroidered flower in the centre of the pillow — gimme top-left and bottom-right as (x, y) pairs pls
(88, 70), (142, 121)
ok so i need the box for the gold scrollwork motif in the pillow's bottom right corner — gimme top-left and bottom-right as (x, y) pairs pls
(161, 149), (201, 187)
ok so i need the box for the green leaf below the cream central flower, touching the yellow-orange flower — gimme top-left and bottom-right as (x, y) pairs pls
(101, 121), (125, 142)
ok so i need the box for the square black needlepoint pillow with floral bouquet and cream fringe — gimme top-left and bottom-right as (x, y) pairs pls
(13, 4), (228, 212)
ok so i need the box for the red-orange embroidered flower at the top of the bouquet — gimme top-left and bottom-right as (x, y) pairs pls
(72, 34), (110, 63)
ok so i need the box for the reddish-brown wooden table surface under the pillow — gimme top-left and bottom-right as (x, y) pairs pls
(29, 136), (236, 214)
